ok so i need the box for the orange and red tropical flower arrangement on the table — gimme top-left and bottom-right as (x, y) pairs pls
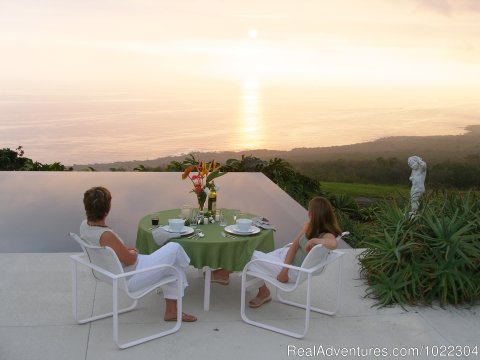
(182, 156), (226, 210)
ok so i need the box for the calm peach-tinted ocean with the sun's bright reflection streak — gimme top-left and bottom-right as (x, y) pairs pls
(0, 82), (480, 165)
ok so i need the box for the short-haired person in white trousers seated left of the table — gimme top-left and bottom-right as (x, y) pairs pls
(80, 186), (197, 322)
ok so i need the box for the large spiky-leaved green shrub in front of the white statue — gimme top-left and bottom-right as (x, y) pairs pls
(359, 192), (480, 306)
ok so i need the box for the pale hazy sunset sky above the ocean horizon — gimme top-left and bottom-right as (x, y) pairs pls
(0, 0), (480, 91)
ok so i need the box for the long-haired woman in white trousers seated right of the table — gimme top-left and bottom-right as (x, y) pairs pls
(213, 196), (342, 308)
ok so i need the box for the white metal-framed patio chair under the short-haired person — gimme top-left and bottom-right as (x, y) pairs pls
(70, 233), (182, 349)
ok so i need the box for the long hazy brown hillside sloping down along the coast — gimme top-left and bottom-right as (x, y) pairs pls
(73, 125), (480, 171)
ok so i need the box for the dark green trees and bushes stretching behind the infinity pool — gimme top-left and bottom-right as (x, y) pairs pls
(0, 146), (480, 190)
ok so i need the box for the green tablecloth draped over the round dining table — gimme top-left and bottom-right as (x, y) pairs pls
(136, 209), (275, 271)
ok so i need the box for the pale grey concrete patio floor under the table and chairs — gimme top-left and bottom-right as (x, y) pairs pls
(0, 249), (480, 360)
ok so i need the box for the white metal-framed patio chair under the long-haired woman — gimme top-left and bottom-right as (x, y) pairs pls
(240, 232), (349, 339)
